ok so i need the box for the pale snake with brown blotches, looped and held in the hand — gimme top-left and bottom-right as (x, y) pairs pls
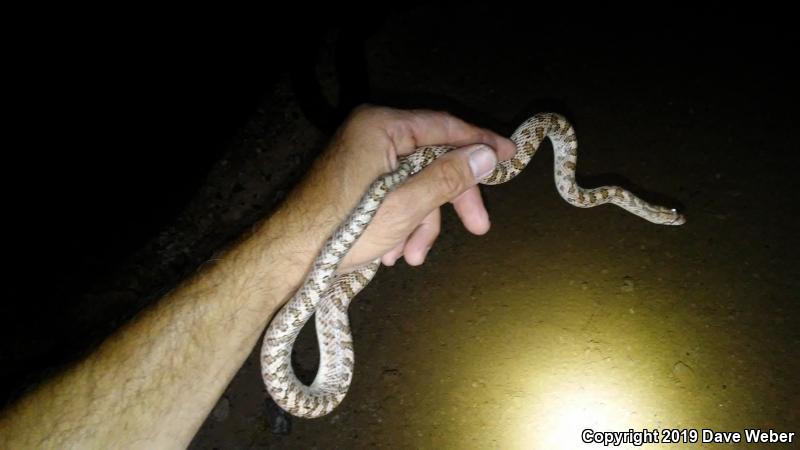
(260, 112), (686, 418)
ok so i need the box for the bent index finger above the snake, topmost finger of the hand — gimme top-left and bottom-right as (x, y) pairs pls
(386, 110), (517, 160)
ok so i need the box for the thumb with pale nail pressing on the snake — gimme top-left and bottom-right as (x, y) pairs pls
(396, 144), (497, 223)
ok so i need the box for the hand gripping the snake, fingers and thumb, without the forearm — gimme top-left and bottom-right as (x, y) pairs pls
(322, 107), (516, 271)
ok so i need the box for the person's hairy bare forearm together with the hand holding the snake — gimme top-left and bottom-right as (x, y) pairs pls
(0, 104), (513, 448)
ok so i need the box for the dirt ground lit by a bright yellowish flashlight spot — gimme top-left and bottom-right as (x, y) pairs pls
(4, 5), (800, 449)
